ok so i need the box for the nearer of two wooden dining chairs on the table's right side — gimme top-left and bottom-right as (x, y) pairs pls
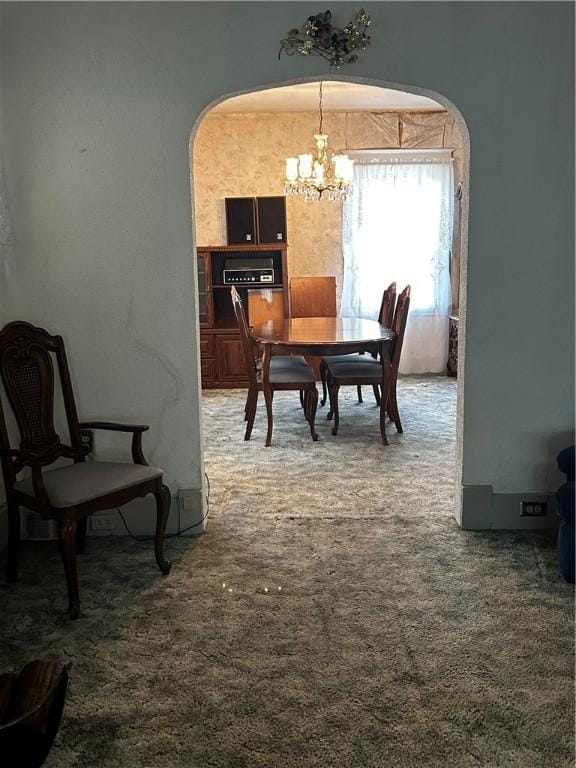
(327, 285), (410, 443)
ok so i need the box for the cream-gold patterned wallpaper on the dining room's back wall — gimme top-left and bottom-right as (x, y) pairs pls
(191, 112), (463, 306)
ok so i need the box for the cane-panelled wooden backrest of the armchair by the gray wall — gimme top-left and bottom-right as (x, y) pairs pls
(0, 321), (85, 482)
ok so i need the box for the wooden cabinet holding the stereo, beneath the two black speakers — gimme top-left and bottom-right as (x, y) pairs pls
(197, 244), (288, 389)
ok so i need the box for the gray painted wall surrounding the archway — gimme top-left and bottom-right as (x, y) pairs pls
(2, 2), (574, 520)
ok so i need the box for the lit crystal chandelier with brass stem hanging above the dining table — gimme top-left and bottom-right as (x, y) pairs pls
(284, 82), (353, 200)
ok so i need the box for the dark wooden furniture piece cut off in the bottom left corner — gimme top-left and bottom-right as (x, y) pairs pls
(0, 660), (70, 768)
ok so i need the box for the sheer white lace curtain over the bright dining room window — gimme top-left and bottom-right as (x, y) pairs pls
(341, 150), (454, 373)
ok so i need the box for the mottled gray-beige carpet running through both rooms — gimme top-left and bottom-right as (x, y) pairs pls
(0, 377), (574, 768)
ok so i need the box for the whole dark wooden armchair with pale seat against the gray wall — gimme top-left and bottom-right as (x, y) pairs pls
(0, 322), (170, 619)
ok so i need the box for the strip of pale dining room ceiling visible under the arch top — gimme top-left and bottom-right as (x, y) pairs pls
(211, 80), (444, 114)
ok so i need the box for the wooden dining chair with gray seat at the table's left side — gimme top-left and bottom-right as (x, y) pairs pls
(230, 286), (318, 447)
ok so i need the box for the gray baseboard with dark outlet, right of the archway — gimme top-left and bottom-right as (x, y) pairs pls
(460, 485), (559, 531)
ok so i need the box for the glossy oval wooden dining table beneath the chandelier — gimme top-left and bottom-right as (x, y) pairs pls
(250, 317), (396, 446)
